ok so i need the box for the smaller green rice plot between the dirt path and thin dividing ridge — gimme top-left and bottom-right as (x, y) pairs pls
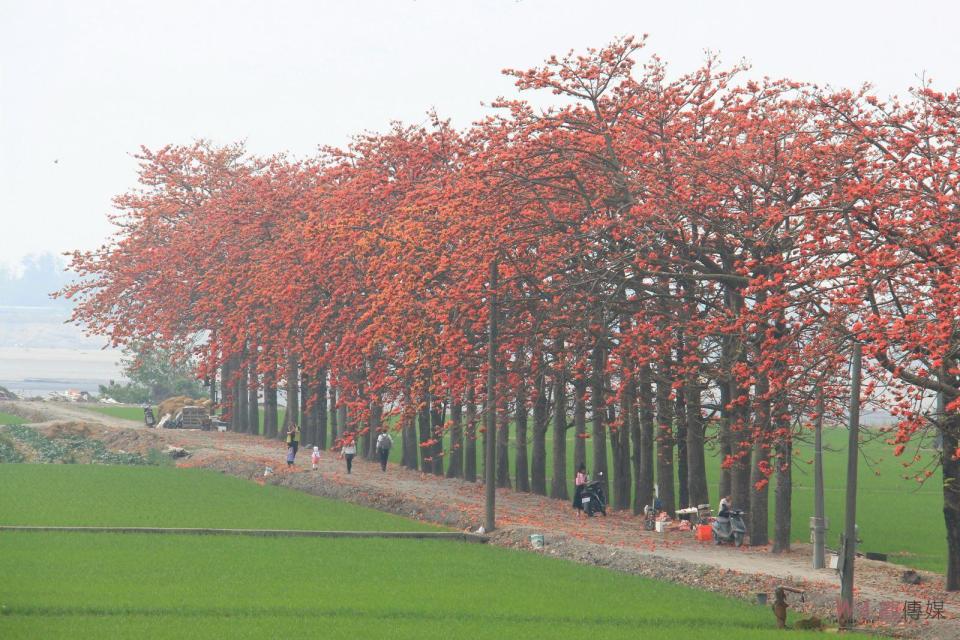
(0, 464), (435, 531)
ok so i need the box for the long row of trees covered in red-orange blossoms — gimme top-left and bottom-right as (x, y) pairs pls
(64, 38), (960, 589)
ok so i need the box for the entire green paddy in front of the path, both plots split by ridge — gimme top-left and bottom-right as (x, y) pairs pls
(0, 464), (824, 639)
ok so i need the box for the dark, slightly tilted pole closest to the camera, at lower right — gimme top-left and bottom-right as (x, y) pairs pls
(839, 342), (861, 628)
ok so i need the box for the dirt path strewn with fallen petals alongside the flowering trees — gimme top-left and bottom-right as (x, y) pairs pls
(0, 401), (960, 639)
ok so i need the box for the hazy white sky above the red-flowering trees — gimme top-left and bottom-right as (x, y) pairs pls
(0, 0), (960, 270)
